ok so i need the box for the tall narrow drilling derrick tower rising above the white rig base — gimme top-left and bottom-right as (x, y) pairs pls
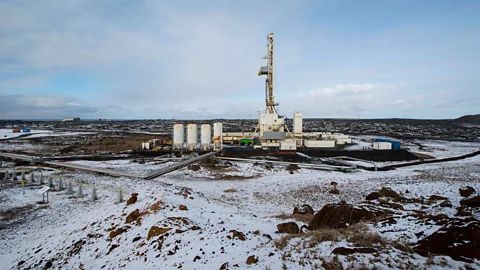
(258, 33), (278, 114)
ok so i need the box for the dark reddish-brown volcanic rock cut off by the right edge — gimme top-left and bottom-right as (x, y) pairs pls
(414, 218), (480, 262)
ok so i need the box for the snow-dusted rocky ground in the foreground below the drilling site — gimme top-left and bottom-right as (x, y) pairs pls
(0, 139), (480, 269)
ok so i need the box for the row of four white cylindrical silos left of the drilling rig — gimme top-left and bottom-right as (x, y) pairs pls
(172, 123), (223, 150)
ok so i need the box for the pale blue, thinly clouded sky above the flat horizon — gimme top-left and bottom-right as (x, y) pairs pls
(0, 0), (480, 119)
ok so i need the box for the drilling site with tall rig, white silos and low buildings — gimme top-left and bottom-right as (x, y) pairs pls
(141, 33), (408, 158)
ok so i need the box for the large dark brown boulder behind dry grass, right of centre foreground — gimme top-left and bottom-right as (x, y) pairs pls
(308, 201), (391, 230)
